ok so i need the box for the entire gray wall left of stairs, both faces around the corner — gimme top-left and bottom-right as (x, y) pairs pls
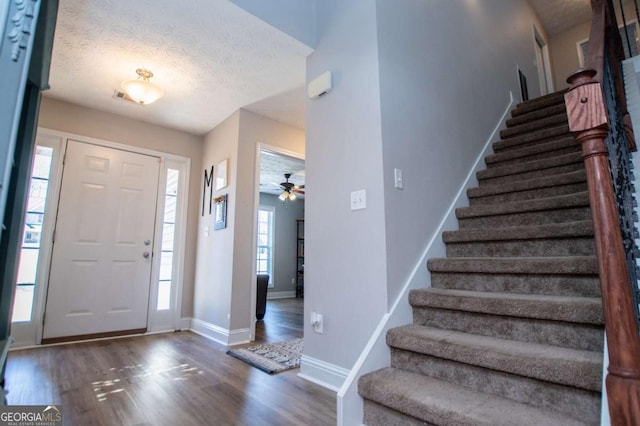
(302, 0), (552, 374)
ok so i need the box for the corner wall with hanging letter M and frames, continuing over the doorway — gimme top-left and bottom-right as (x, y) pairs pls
(194, 109), (305, 343)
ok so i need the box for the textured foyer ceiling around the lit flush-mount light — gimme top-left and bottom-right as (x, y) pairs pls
(46, 0), (311, 134)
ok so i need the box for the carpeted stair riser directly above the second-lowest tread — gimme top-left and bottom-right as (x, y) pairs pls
(413, 307), (604, 351)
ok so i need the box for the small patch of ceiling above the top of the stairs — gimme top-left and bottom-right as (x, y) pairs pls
(529, 0), (591, 37)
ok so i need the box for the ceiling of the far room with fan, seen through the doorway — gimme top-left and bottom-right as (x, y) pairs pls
(260, 151), (304, 195)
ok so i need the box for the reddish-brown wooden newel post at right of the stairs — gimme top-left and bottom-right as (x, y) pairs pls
(565, 69), (640, 426)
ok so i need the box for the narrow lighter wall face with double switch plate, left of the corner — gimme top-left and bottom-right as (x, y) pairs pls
(301, 0), (388, 372)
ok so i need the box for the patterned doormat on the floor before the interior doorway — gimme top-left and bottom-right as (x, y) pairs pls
(227, 339), (304, 374)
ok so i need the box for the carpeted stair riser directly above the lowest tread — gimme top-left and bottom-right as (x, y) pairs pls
(391, 348), (600, 419)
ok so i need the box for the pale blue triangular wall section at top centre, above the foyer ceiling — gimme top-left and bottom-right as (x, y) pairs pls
(231, 0), (316, 47)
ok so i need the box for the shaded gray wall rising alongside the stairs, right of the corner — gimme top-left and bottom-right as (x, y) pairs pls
(377, 0), (541, 310)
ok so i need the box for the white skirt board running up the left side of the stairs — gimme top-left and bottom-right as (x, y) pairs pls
(337, 92), (515, 426)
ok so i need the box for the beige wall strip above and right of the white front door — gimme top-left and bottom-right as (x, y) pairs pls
(38, 97), (202, 317)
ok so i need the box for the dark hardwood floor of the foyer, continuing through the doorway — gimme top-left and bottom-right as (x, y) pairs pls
(6, 299), (336, 426)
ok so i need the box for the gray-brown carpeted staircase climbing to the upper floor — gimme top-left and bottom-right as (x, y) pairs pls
(358, 93), (603, 426)
